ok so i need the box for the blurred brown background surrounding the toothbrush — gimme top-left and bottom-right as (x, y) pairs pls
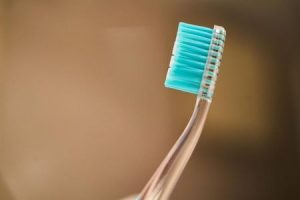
(0, 0), (300, 200)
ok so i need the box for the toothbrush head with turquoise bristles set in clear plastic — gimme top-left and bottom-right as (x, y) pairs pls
(165, 22), (226, 100)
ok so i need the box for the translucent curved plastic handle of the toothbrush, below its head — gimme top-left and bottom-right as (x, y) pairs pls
(136, 97), (210, 200)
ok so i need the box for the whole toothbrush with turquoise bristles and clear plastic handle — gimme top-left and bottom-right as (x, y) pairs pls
(136, 22), (226, 200)
